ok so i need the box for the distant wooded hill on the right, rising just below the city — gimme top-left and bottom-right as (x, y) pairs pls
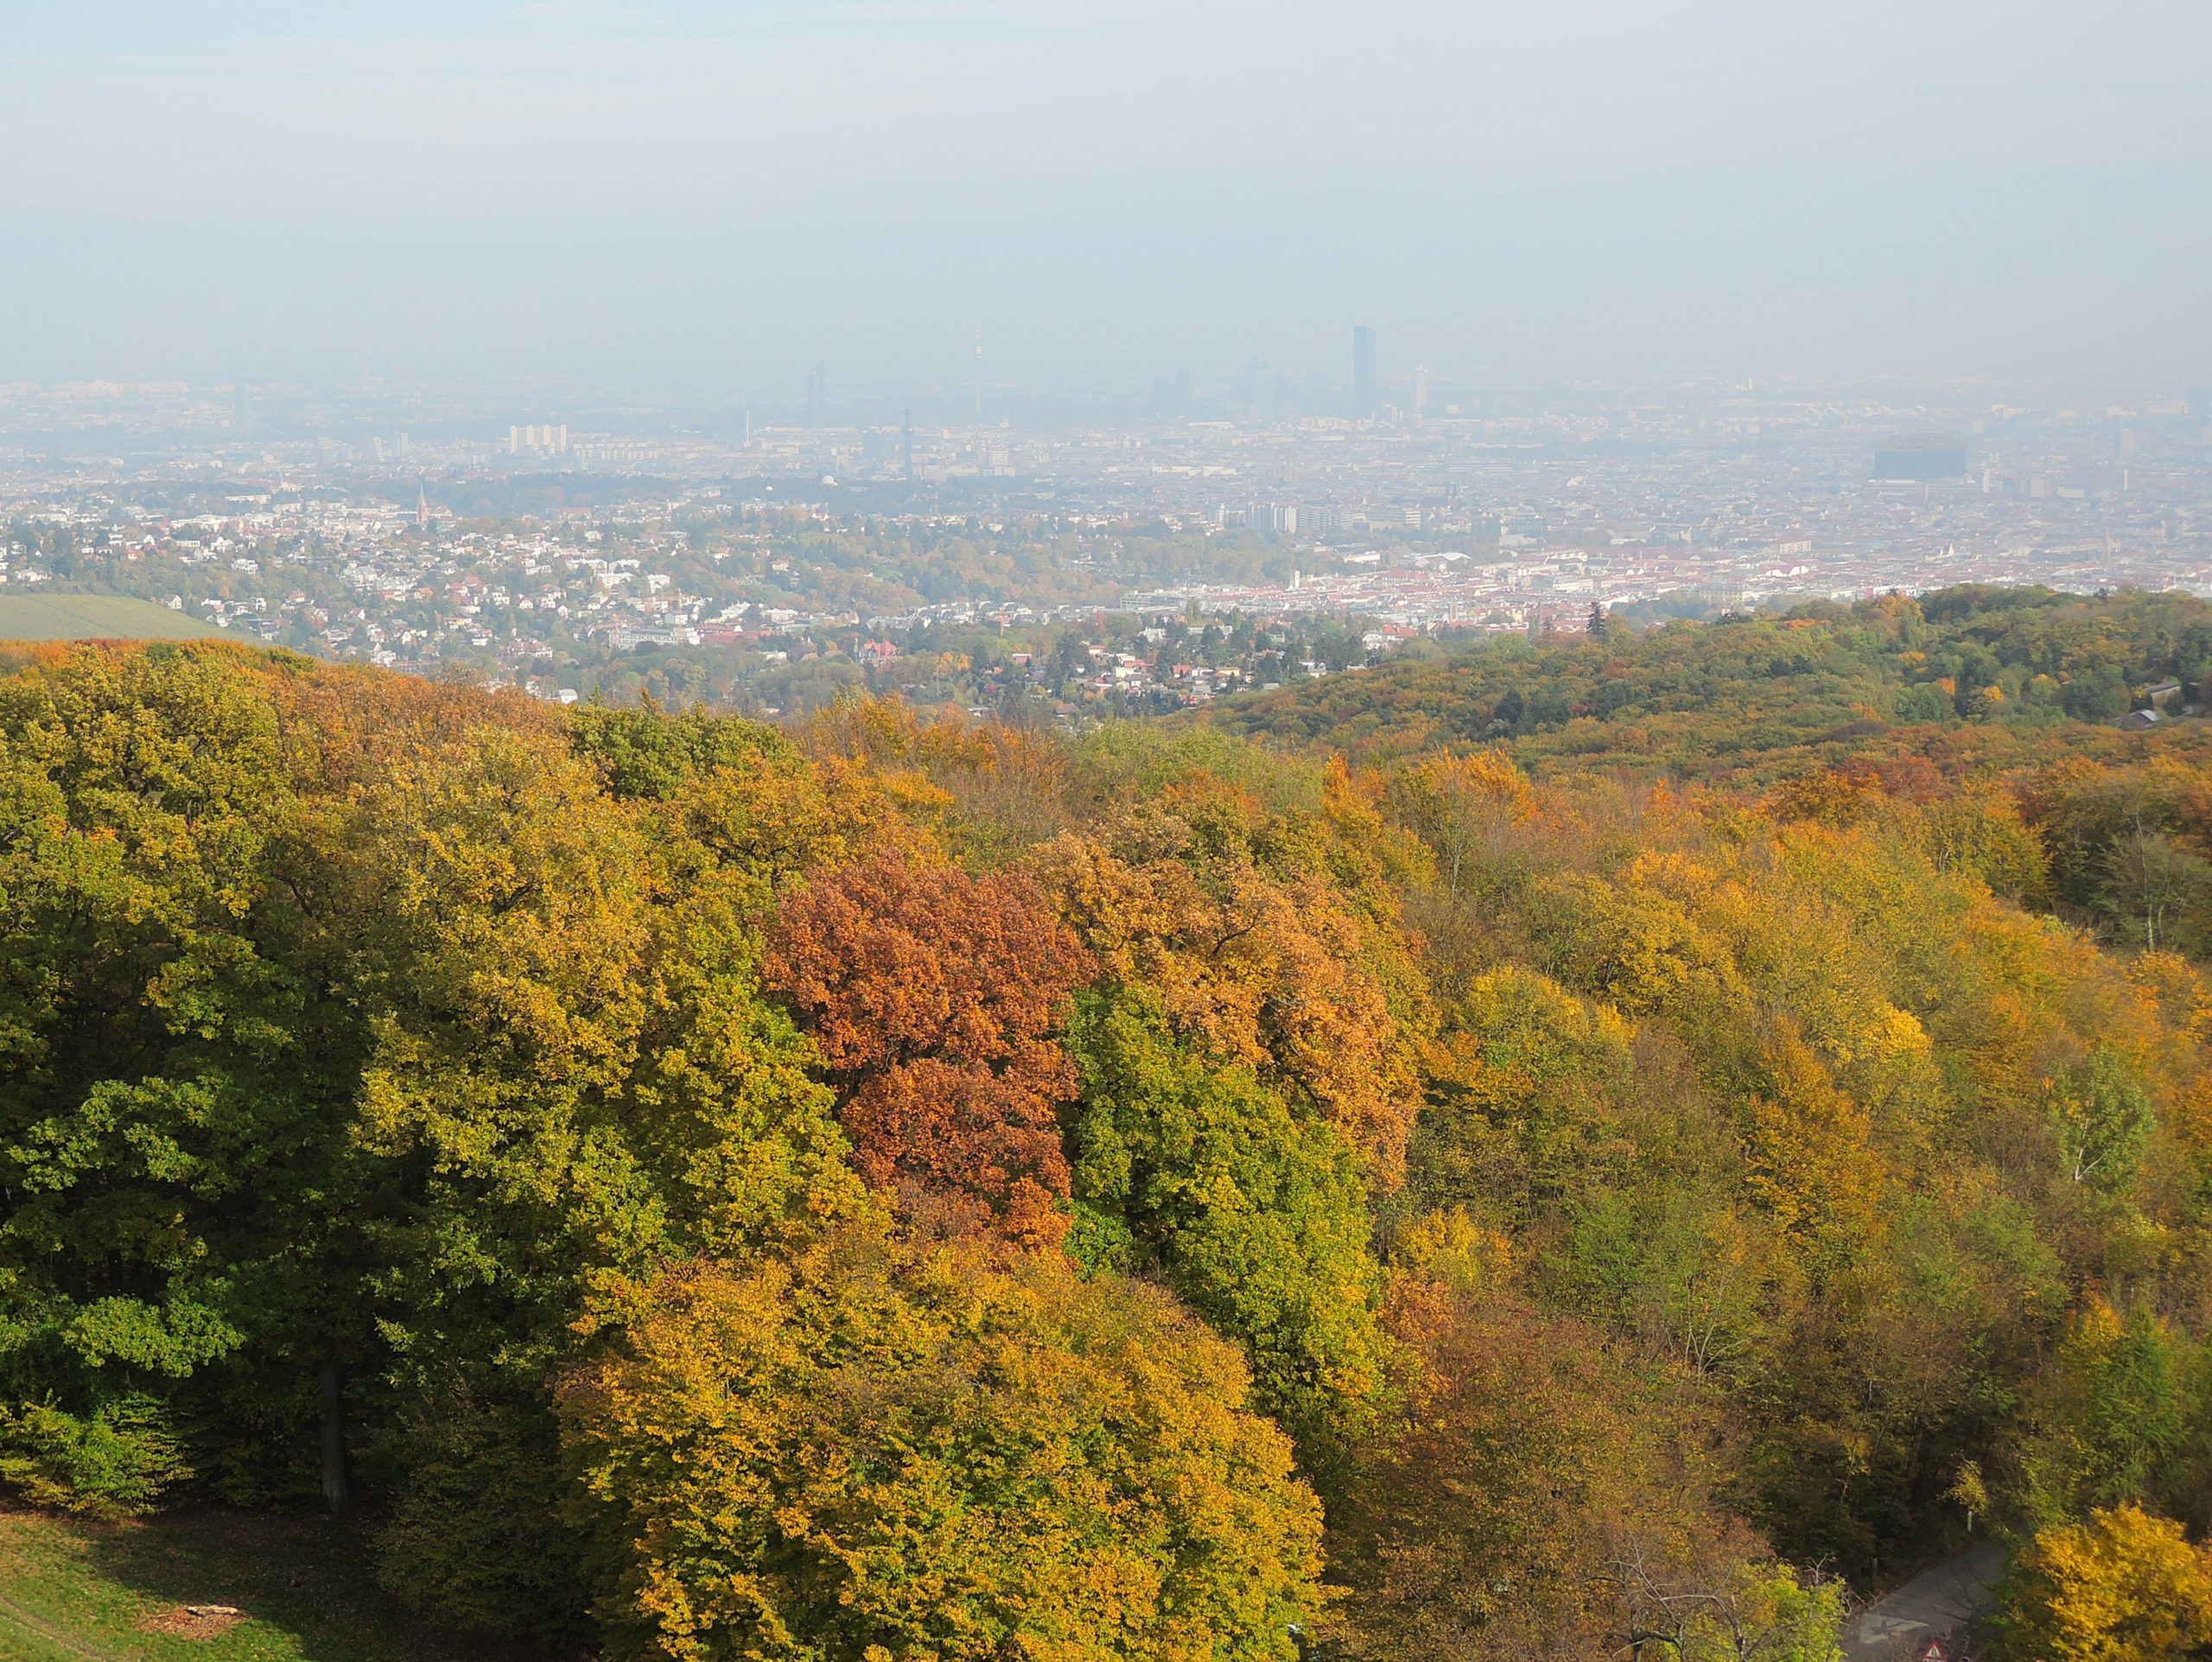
(1205, 586), (2212, 783)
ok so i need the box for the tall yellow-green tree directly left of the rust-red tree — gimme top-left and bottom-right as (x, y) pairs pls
(356, 715), (861, 1631)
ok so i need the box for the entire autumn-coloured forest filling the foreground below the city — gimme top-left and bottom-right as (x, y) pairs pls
(13, 590), (2212, 1662)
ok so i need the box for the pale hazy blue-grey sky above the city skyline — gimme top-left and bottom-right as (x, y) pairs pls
(0, 0), (2212, 398)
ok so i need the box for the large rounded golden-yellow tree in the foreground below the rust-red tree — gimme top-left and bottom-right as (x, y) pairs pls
(562, 1224), (1320, 1662)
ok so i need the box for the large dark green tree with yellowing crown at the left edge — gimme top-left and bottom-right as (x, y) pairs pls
(0, 648), (383, 1499)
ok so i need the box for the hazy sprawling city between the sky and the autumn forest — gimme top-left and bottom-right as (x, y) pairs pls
(0, 373), (2212, 712)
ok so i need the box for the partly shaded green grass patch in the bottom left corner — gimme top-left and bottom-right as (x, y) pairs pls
(0, 1509), (511, 1662)
